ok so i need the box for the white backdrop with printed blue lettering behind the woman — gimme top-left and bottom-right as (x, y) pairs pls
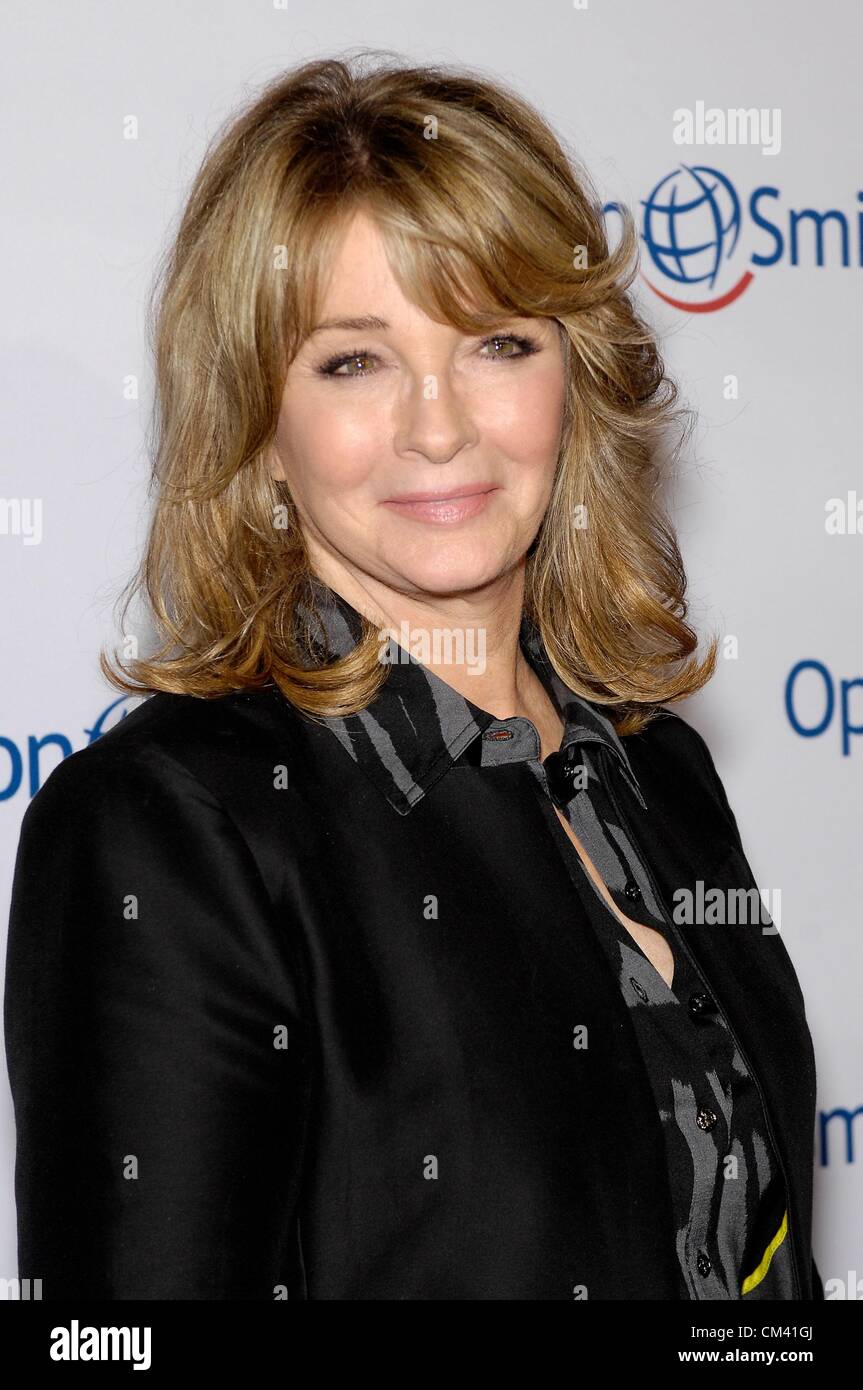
(0, 0), (863, 1298)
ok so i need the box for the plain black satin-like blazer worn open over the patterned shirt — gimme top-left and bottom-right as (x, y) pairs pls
(6, 644), (823, 1300)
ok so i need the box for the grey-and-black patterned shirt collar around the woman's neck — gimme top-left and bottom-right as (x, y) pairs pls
(297, 575), (646, 815)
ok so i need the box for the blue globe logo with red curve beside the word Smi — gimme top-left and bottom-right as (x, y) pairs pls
(642, 164), (752, 309)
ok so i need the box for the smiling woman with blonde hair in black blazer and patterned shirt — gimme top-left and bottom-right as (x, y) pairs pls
(6, 51), (823, 1300)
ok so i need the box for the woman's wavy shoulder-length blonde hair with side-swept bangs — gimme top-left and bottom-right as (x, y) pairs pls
(100, 50), (717, 735)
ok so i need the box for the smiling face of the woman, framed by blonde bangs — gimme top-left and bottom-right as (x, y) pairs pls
(270, 213), (566, 595)
